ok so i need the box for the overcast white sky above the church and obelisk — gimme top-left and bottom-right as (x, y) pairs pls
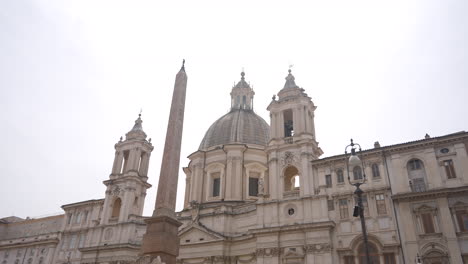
(0, 0), (468, 217)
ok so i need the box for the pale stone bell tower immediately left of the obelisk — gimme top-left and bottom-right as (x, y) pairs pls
(101, 114), (153, 225)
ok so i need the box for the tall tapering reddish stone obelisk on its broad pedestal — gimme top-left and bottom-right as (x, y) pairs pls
(141, 60), (187, 264)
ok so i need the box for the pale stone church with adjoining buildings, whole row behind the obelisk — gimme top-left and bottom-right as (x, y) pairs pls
(0, 71), (468, 264)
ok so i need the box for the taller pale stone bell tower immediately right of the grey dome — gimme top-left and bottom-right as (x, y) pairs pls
(267, 69), (323, 199)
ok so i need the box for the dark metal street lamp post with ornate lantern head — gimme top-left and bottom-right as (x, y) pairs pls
(345, 139), (371, 264)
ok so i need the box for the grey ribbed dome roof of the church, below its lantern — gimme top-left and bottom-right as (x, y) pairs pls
(199, 109), (270, 149)
